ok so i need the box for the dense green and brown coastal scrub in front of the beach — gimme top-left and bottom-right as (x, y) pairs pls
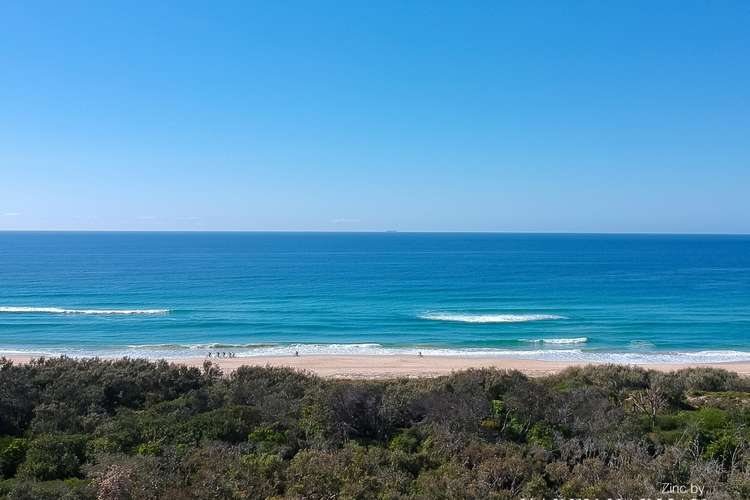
(0, 358), (750, 500)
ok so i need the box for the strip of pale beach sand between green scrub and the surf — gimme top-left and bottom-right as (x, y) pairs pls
(8, 355), (750, 378)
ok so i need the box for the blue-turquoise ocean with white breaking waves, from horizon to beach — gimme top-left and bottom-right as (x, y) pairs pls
(0, 232), (750, 362)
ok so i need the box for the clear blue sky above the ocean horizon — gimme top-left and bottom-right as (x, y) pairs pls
(0, 0), (750, 233)
